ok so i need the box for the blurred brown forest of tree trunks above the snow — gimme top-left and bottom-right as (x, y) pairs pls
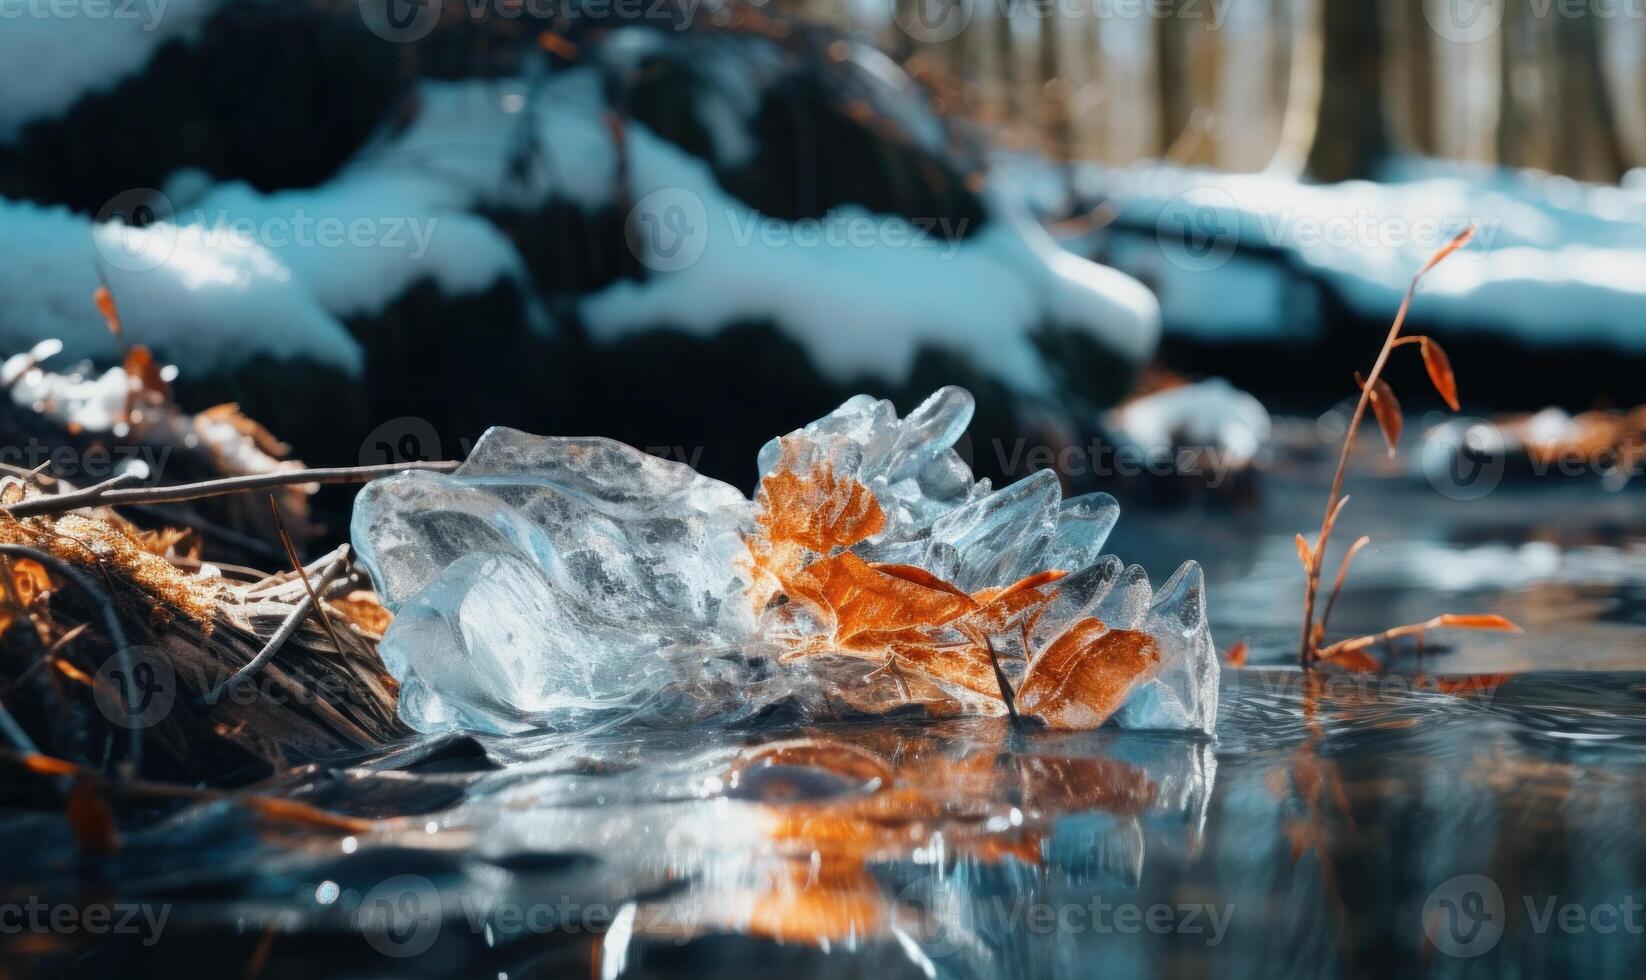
(842, 0), (1646, 183)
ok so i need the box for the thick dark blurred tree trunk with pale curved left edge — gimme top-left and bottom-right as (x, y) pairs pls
(1307, 0), (1391, 181)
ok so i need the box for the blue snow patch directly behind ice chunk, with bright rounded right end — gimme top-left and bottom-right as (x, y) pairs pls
(583, 101), (1159, 392)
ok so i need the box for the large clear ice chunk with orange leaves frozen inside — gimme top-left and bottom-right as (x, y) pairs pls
(351, 387), (1218, 733)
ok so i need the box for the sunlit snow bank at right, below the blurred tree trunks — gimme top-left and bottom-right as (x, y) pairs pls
(1053, 161), (1646, 351)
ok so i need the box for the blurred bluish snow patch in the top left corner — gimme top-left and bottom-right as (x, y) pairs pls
(0, 0), (222, 143)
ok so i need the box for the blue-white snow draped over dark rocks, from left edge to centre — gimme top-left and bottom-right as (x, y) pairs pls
(0, 52), (1160, 394)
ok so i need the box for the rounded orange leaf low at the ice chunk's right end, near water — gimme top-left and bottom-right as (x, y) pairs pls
(1017, 619), (1160, 728)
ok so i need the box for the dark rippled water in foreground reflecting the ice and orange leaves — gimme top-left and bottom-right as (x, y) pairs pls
(0, 670), (1646, 978)
